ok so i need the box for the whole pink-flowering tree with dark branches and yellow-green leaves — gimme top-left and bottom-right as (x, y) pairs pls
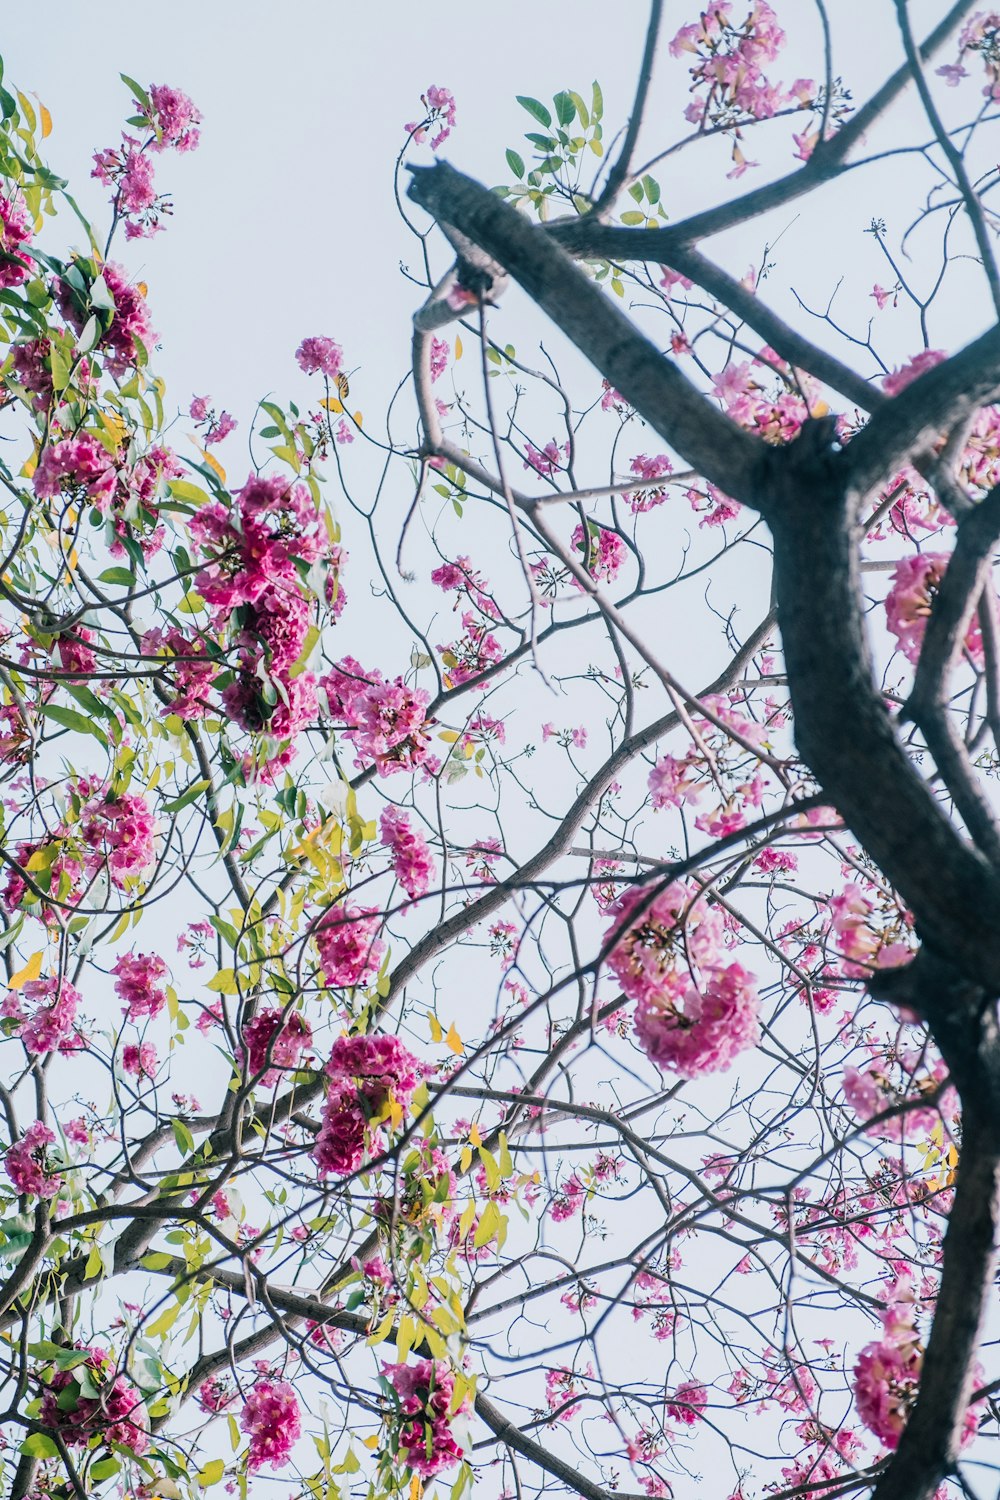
(0, 0), (1000, 1500)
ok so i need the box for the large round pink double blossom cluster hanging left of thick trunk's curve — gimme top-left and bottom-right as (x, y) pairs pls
(606, 882), (760, 1079)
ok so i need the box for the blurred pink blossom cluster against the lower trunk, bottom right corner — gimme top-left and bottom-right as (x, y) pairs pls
(855, 1269), (984, 1449)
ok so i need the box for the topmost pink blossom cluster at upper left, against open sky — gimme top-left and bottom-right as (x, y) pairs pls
(90, 84), (201, 240)
